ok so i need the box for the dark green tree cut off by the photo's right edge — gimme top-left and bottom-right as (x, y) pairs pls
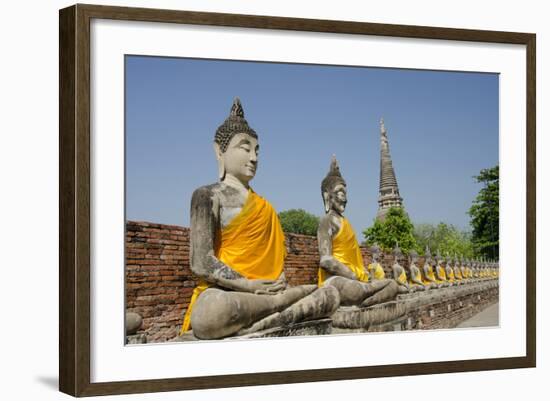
(468, 165), (499, 259)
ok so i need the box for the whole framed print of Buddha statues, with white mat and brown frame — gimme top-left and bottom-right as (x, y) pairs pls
(59, 5), (536, 396)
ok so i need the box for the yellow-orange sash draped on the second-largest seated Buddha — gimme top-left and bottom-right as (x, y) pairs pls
(318, 217), (369, 287)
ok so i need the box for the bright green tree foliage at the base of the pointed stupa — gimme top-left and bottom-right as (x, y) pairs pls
(363, 207), (418, 253)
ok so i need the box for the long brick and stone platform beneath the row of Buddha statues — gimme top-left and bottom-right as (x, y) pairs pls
(138, 279), (499, 344)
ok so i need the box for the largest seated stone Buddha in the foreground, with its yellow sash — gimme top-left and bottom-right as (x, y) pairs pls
(180, 98), (339, 339)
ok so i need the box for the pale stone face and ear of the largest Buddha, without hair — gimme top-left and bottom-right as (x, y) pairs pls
(214, 133), (260, 184)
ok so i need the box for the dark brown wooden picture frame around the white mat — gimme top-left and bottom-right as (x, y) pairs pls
(59, 5), (536, 396)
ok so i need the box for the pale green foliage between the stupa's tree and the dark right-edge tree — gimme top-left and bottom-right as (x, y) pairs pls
(414, 223), (474, 258)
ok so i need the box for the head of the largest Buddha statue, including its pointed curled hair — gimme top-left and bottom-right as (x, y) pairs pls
(214, 98), (260, 185)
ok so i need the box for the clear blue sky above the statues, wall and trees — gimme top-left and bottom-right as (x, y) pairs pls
(126, 56), (499, 233)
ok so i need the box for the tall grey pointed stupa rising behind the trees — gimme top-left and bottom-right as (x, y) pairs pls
(376, 118), (403, 220)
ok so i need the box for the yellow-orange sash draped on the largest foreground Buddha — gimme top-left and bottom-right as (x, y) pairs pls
(180, 190), (286, 334)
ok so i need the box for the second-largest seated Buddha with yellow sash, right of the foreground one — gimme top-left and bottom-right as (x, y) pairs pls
(317, 156), (397, 306)
